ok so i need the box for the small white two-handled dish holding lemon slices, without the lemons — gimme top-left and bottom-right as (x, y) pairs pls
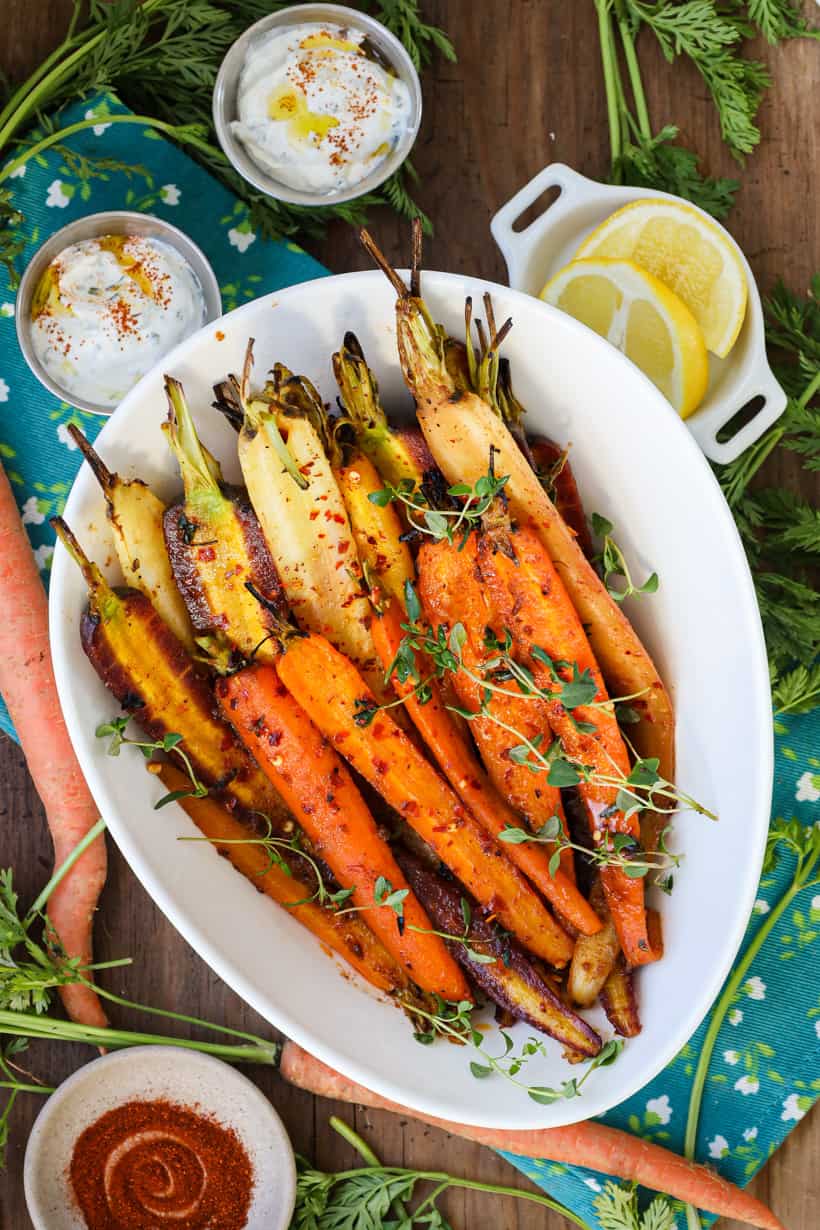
(491, 162), (786, 464)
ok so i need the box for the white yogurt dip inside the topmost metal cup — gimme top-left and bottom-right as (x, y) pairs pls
(231, 22), (412, 194)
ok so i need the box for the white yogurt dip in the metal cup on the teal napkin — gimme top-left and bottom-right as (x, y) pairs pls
(31, 235), (207, 407)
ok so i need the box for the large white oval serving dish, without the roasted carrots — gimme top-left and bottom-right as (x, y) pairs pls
(50, 272), (772, 1128)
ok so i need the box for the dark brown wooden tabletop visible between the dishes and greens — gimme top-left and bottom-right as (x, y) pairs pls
(0, 0), (820, 1230)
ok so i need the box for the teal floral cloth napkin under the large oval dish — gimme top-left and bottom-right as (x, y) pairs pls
(0, 95), (820, 1226)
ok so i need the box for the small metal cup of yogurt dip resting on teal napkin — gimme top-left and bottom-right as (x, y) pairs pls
(15, 210), (223, 415)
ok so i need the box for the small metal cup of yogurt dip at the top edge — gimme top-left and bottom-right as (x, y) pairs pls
(214, 4), (422, 205)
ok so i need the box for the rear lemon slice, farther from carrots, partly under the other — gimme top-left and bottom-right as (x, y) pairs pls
(574, 199), (747, 358)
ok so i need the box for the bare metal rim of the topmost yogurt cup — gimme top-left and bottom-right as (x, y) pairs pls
(213, 4), (422, 207)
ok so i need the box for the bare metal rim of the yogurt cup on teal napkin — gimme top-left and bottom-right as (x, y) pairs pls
(15, 209), (223, 418)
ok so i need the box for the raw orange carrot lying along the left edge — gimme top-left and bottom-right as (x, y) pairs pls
(0, 466), (108, 1027)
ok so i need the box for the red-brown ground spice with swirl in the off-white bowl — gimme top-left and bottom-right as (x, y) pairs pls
(70, 1100), (253, 1230)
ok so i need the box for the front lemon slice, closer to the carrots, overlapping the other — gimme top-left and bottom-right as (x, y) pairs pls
(541, 261), (709, 418)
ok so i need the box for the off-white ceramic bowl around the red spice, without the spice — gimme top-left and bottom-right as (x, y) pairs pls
(23, 1044), (296, 1230)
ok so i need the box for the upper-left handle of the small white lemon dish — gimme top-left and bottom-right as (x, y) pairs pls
(489, 162), (606, 290)
